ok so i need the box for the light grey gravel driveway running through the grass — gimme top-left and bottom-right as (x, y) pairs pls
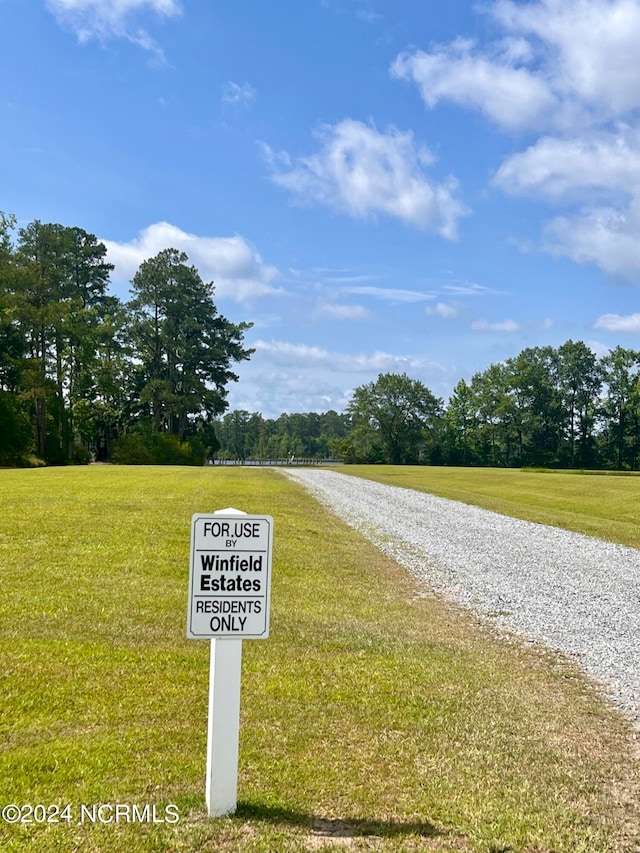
(285, 469), (640, 723)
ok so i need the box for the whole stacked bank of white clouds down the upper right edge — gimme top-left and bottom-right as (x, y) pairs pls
(391, 0), (640, 283)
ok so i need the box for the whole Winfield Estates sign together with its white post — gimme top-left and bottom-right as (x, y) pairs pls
(187, 509), (273, 817)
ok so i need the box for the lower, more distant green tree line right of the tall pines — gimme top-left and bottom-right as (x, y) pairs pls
(216, 340), (640, 471)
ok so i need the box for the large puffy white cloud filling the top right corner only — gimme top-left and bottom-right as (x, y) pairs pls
(391, 0), (640, 131)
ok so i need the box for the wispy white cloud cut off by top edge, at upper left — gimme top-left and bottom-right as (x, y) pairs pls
(46, 0), (182, 53)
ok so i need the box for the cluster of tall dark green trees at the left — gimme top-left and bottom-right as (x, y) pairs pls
(0, 214), (253, 465)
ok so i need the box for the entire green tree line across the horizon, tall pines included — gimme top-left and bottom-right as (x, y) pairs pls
(0, 213), (640, 470)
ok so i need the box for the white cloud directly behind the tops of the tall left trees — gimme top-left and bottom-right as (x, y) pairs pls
(103, 222), (281, 302)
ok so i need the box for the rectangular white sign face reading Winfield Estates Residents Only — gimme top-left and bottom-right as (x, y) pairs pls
(187, 513), (273, 640)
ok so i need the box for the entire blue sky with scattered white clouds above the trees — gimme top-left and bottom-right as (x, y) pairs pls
(0, 0), (640, 417)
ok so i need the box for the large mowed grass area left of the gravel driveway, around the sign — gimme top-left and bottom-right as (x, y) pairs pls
(0, 466), (640, 853)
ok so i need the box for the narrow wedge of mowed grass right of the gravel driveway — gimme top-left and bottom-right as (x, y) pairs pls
(340, 465), (640, 548)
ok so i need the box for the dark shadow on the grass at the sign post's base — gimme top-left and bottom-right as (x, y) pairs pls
(235, 801), (449, 838)
